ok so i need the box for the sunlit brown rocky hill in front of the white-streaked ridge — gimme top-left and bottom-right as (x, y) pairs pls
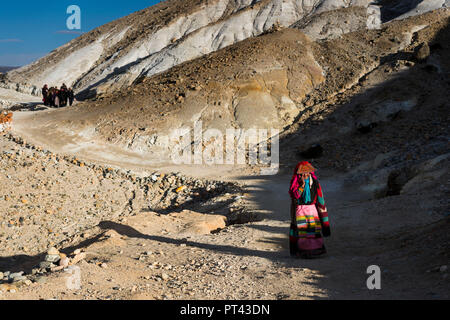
(9, 8), (449, 168)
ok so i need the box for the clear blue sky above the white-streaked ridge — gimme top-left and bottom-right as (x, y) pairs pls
(0, 0), (160, 66)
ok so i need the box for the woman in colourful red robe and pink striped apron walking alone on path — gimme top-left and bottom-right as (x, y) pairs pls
(289, 161), (331, 258)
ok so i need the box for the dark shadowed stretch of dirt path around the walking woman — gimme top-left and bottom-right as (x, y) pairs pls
(239, 172), (448, 299)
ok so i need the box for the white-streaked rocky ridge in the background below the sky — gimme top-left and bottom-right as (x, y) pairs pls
(3, 0), (448, 97)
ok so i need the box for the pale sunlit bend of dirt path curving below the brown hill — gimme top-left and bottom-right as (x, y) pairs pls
(12, 108), (246, 178)
